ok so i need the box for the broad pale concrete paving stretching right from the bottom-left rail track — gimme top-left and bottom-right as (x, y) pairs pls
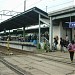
(0, 51), (75, 75)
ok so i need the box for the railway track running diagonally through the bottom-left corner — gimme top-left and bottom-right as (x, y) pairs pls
(0, 56), (31, 75)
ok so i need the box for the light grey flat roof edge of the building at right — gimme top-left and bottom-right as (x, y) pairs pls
(49, 6), (75, 20)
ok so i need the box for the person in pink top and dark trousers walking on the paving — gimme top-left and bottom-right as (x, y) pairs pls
(68, 41), (75, 62)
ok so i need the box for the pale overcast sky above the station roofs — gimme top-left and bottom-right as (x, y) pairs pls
(0, 0), (74, 21)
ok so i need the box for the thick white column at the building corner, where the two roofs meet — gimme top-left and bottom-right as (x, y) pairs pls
(49, 17), (53, 50)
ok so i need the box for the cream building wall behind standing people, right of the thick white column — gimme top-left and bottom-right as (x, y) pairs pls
(53, 22), (72, 50)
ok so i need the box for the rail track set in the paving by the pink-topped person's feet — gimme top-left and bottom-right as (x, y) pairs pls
(34, 54), (75, 67)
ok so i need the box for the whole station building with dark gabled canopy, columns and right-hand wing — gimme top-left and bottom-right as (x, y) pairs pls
(0, 1), (75, 49)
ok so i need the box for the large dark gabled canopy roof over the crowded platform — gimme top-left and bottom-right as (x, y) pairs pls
(0, 7), (49, 31)
